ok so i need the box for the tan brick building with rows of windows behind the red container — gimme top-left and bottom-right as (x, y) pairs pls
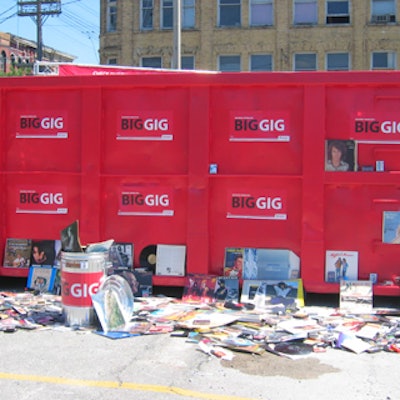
(100, 0), (400, 71)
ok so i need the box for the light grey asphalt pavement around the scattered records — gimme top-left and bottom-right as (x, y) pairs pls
(0, 279), (400, 400)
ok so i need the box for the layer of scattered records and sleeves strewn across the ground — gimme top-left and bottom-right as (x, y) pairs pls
(0, 291), (400, 363)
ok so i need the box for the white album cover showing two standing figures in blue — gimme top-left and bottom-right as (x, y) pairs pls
(325, 250), (358, 283)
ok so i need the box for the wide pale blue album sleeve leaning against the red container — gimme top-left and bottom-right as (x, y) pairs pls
(243, 248), (300, 280)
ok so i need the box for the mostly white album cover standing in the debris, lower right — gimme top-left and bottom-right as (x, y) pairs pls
(339, 280), (373, 314)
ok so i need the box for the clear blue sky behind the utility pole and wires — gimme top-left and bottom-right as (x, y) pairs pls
(0, 0), (100, 64)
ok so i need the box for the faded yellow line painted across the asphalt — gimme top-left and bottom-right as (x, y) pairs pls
(0, 372), (256, 400)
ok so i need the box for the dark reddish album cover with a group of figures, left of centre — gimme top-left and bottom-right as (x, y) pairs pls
(182, 274), (218, 303)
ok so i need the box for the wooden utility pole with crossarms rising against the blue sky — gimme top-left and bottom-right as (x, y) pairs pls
(17, 0), (61, 61)
